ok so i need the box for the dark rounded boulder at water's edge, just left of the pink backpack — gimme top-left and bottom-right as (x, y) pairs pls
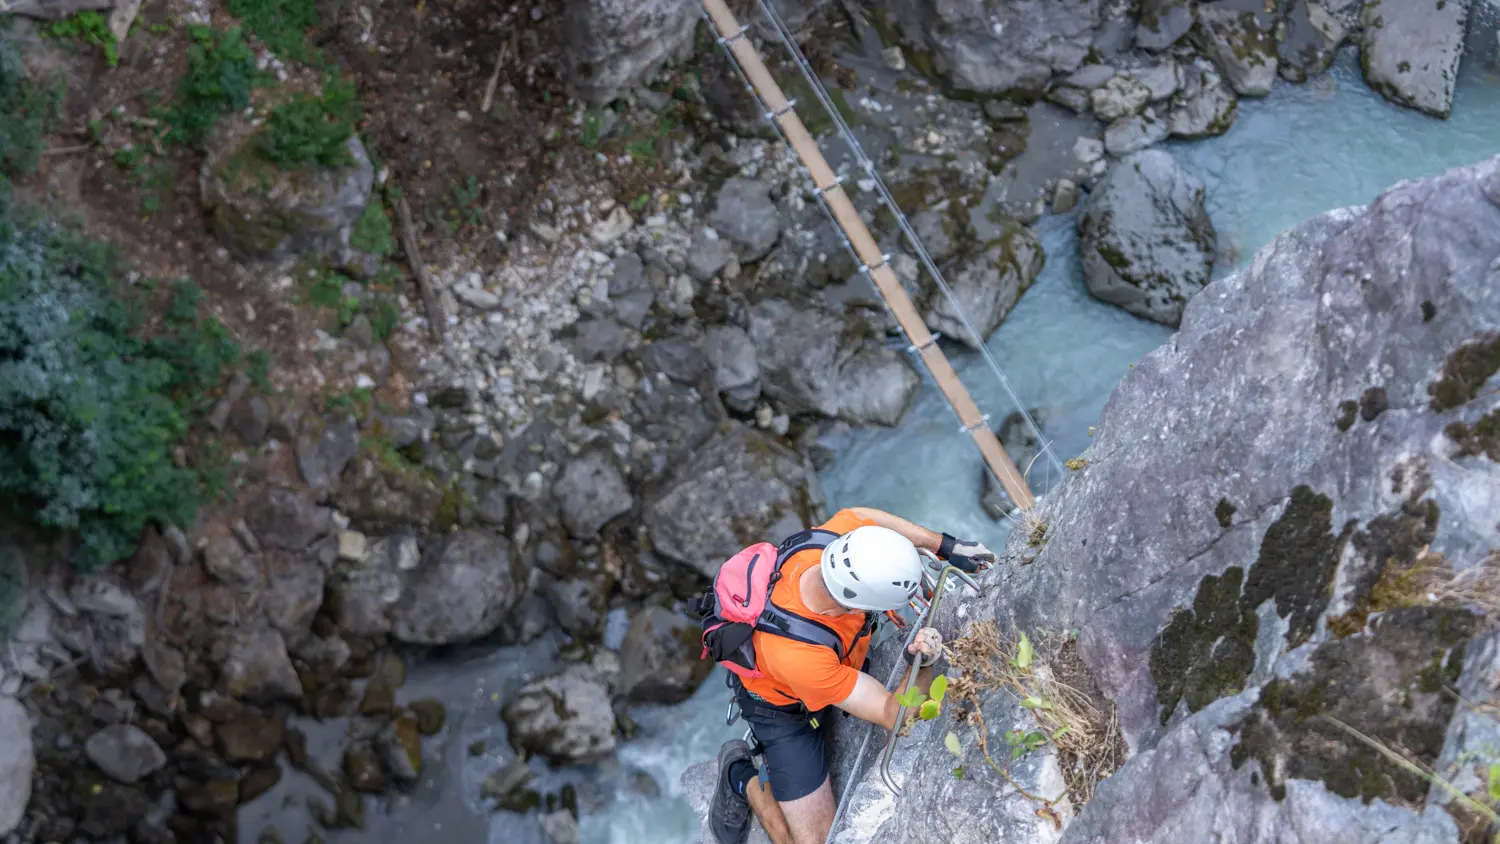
(620, 607), (714, 705)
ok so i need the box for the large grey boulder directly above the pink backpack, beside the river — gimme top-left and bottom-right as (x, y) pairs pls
(642, 424), (812, 577)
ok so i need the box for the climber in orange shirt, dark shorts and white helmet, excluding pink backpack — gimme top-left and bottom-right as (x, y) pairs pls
(708, 507), (995, 844)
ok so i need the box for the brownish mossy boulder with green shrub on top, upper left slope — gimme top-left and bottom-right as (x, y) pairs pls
(198, 115), (375, 259)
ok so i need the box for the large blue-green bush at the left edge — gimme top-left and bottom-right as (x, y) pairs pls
(0, 202), (237, 570)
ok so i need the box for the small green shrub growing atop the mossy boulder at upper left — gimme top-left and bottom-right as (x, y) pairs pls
(255, 75), (363, 169)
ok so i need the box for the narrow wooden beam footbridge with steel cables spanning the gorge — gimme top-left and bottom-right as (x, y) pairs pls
(702, 0), (1064, 511)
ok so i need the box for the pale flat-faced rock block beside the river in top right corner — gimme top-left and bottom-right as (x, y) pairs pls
(1359, 0), (1473, 117)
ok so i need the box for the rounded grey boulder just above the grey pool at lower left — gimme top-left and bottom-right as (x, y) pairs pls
(390, 531), (525, 645)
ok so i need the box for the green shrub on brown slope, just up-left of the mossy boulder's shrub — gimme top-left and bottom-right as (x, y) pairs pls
(165, 27), (260, 147)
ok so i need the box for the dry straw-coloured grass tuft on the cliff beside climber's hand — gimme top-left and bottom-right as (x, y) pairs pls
(948, 621), (1125, 807)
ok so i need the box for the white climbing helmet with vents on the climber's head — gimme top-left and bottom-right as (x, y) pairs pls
(822, 525), (923, 612)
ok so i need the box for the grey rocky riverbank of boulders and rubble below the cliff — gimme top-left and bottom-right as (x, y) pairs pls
(0, 0), (1482, 844)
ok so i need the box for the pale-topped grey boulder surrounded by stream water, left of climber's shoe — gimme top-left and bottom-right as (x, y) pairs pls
(501, 666), (615, 765)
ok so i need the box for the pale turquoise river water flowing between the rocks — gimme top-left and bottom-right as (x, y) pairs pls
(242, 13), (1500, 844)
